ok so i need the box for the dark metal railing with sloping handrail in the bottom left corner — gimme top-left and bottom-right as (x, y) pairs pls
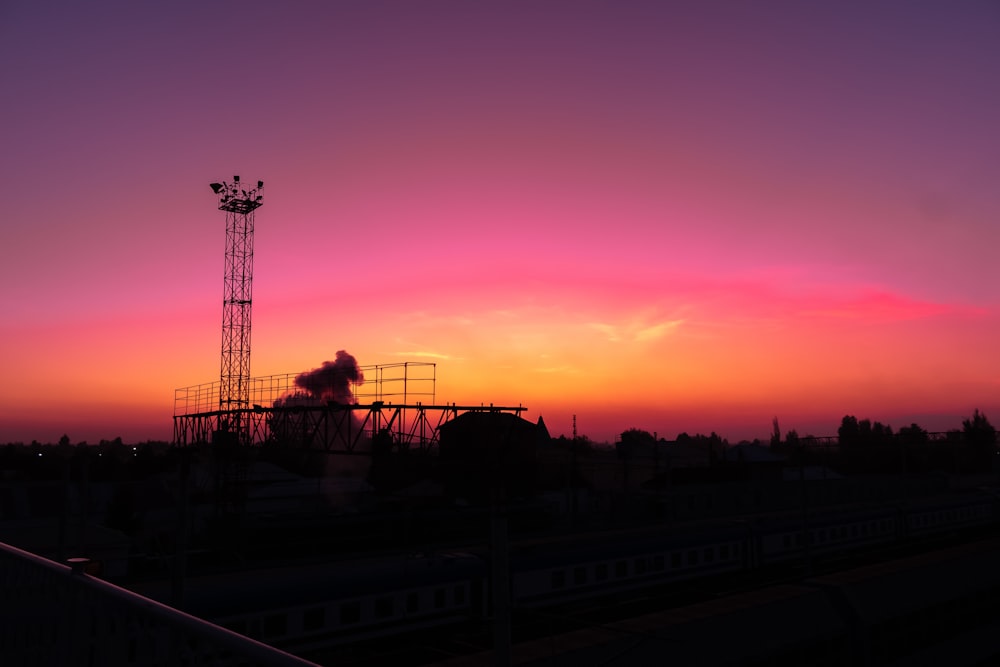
(0, 543), (316, 667)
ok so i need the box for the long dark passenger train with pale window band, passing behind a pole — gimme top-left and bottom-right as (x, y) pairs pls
(135, 492), (1000, 652)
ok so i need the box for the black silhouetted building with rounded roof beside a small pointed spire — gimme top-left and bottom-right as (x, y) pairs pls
(438, 412), (549, 503)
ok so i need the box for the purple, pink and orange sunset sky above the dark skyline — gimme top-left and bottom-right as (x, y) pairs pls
(0, 0), (1000, 443)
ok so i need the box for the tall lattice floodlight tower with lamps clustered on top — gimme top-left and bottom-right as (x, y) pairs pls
(211, 176), (264, 444)
